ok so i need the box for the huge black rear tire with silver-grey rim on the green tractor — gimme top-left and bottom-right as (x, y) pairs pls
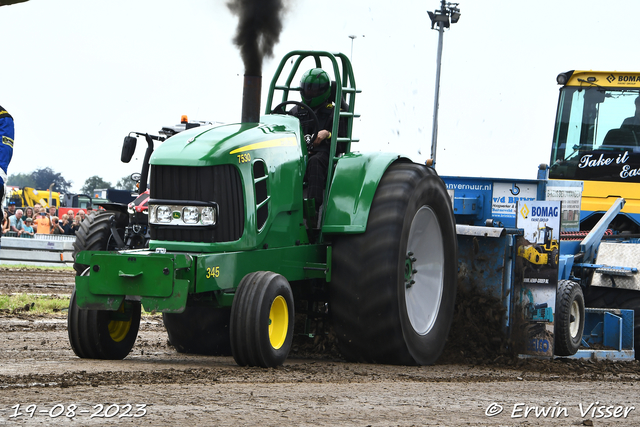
(329, 163), (458, 365)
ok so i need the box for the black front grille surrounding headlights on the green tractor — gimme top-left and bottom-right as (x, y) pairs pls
(150, 165), (244, 243)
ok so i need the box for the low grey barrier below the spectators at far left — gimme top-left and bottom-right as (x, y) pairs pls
(0, 233), (76, 265)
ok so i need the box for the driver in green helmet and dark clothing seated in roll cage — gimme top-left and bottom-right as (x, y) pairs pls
(289, 68), (347, 211)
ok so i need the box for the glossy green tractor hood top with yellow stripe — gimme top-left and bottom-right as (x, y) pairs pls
(150, 115), (301, 167)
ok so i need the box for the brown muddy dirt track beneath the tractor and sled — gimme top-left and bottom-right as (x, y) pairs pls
(0, 269), (640, 427)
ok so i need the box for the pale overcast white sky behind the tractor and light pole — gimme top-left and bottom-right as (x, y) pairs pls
(0, 0), (640, 191)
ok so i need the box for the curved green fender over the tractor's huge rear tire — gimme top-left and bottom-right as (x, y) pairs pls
(322, 152), (410, 234)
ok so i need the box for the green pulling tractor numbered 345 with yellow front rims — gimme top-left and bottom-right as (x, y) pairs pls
(68, 51), (457, 367)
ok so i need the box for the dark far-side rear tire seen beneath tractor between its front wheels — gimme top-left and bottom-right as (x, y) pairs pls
(162, 302), (231, 356)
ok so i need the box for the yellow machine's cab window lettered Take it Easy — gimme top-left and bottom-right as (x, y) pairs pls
(549, 85), (640, 182)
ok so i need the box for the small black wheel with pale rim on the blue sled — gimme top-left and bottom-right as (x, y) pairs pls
(554, 280), (584, 356)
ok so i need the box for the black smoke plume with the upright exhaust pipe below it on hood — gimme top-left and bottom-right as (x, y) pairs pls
(227, 0), (286, 123)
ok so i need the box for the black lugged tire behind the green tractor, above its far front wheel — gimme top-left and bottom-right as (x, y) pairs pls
(73, 211), (129, 275)
